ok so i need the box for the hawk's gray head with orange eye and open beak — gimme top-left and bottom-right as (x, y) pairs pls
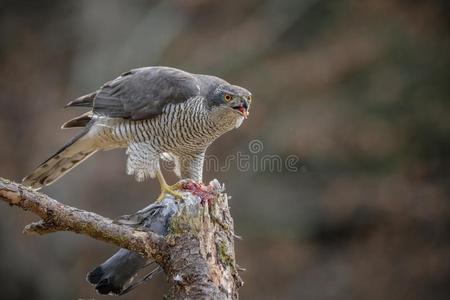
(210, 84), (252, 119)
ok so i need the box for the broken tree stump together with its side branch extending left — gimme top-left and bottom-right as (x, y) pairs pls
(0, 178), (243, 299)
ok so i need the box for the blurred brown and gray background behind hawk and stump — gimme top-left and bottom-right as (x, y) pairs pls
(0, 0), (450, 300)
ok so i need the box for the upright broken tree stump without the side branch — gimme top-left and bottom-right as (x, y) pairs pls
(163, 181), (243, 299)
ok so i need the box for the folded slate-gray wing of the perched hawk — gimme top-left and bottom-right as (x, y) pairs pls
(67, 67), (200, 120)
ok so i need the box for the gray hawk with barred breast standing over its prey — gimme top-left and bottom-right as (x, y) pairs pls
(23, 67), (252, 200)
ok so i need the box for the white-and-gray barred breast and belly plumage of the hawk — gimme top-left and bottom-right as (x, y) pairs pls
(90, 97), (243, 181)
